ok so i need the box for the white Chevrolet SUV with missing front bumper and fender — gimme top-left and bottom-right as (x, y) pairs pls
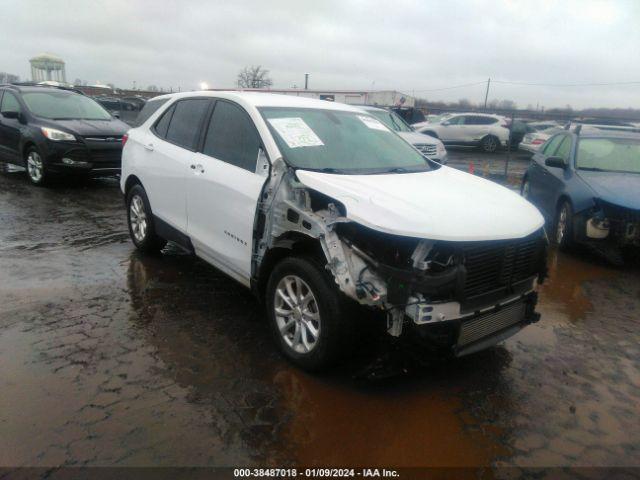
(121, 92), (546, 370)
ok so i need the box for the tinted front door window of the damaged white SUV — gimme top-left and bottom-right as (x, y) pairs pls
(202, 101), (260, 172)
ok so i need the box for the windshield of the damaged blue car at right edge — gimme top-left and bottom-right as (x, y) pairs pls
(576, 138), (640, 173)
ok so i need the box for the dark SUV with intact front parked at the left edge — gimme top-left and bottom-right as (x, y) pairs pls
(0, 85), (129, 185)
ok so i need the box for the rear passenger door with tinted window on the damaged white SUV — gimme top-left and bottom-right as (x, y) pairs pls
(142, 97), (211, 232)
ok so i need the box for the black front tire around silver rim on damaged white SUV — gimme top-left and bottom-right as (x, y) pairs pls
(265, 257), (355, 371)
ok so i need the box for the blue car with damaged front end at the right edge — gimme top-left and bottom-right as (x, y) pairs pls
(522, 126), (640, 258)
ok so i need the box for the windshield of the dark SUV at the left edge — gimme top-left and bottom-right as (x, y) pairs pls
(22, 91), (111, 120)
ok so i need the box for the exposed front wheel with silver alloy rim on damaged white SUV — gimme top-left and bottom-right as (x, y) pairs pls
(265, 257), (352, 371)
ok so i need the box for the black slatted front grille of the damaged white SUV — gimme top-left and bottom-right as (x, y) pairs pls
(463, 232), (542, 299)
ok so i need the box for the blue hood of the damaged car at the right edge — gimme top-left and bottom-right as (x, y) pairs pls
(578, 170), (640, 210)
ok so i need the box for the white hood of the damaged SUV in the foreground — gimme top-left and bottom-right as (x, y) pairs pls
(296, 167), (544, 241)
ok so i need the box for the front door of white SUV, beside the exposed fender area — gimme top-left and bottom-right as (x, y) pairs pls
(187, 100), (266, 284)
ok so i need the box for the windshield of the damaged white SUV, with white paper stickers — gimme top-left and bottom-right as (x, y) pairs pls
(260, 107), (432, 174)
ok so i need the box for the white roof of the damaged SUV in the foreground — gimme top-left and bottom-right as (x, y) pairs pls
(146, 90), (362, 112)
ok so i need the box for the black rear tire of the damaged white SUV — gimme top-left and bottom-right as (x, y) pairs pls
(127, 185), (167, 253)
